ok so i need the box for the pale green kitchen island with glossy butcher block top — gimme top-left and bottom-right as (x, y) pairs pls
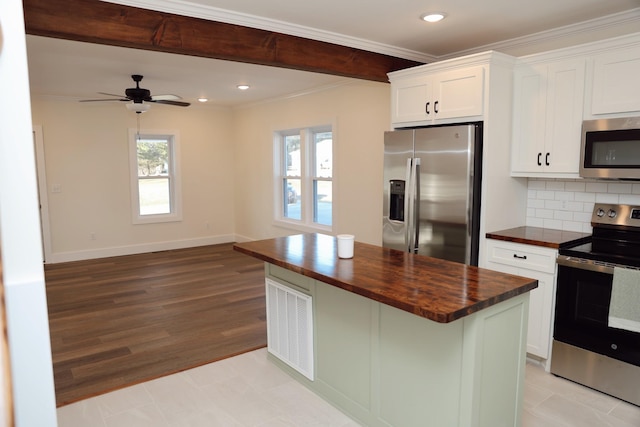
(234, 234), (537, 427)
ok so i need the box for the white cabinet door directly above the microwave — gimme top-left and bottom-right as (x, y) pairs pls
(591, 48), (640, 114)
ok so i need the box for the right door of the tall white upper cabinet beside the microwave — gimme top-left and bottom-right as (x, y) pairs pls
(542, 60), (585, 175)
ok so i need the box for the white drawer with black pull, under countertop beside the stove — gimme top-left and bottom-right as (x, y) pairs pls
(487, 239), (558, 273)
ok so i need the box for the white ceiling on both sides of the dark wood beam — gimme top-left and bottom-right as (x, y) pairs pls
(27, 0), (640, 106)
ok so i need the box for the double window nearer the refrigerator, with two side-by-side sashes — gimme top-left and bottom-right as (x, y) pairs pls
(275, 127), (333, 230)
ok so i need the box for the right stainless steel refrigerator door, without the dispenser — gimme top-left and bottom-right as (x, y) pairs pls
(414, 125), (475, 264)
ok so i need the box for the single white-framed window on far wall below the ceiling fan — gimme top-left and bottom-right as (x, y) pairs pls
(129, 130), (182, 224)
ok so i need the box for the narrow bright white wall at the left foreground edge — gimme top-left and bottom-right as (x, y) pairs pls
(0, 0), (57, 427)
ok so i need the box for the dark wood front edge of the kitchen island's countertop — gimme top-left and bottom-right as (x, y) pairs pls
(233, 245), (538, 323)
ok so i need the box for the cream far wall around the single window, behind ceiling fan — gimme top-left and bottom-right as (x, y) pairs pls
(32, 99), (235, 262)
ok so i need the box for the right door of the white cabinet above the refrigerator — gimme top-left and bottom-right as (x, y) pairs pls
(432, 67), (484, 120)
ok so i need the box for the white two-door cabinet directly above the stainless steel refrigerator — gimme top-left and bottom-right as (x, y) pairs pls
(391, 66), (484, 125)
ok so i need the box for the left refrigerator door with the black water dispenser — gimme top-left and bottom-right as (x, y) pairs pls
(382, 130), (414, 251)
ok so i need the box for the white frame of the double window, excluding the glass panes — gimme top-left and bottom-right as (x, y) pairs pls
(273, 124), (336, 233)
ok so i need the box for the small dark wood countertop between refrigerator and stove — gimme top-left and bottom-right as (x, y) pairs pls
(486, 226), (591, 249)
